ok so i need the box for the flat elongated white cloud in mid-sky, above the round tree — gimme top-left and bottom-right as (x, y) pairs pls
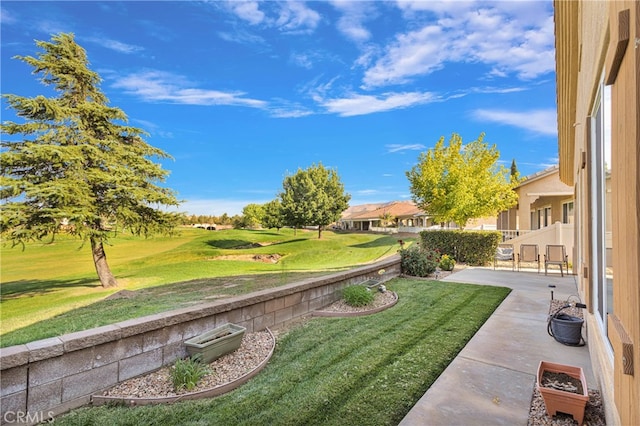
(320, 92), (438, 117)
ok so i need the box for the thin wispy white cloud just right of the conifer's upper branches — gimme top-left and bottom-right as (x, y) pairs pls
(112, 71), (267, 108)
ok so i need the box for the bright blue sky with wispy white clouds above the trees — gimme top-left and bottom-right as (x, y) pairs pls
(0, 0), (558, 215)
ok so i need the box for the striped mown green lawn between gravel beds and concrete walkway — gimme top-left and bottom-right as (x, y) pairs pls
(56, 278), (510, 426)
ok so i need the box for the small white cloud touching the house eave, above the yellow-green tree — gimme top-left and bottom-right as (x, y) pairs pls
(473, 109), (558, 136)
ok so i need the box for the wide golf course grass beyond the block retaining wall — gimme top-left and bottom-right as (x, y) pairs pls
(0, 228), (410, 347)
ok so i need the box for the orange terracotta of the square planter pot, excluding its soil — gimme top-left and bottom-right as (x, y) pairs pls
(536, 361), (589, 425)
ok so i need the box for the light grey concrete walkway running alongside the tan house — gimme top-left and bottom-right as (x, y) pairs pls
(400, 268), (598, 426)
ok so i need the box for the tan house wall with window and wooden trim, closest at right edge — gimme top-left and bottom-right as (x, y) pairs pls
(554, 0), (640, 425)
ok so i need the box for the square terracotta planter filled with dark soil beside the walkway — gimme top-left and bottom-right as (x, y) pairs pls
(536, 361), (589, 425)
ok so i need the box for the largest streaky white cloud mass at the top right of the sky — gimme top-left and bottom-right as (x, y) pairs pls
(363, 1), (555, 87)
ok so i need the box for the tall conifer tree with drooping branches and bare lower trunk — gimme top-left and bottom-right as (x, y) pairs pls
(0, 34), (179, 287)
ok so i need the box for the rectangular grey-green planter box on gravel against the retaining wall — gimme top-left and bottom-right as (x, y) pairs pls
(184, 323), (246, 364)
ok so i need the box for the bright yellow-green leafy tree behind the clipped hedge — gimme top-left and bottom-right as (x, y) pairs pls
(406, 133), (518, 228)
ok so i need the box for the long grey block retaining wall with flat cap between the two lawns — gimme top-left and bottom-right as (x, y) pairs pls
(0, 256), (400, 424)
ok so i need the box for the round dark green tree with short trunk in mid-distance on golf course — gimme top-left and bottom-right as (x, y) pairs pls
(280, 163), (351, 238)
